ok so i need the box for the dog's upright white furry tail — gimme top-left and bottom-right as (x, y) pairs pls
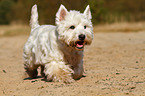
(30, 4), (39, 30)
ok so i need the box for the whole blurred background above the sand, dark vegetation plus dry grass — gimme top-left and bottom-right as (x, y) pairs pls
(0, 0), (145, 37)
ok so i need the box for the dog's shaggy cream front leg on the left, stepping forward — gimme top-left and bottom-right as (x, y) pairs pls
(44, 61), (73, 83)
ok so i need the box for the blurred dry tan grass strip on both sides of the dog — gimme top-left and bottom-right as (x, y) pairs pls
(0, 22), (145, 37)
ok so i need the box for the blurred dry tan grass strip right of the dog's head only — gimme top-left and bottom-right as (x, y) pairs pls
(94, 22), (145, 32)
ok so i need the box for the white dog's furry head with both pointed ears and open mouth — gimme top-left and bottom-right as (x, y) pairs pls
(56, 5), (93, 50)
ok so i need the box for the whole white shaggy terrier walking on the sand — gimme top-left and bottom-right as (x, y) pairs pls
(23, 5), (93, 83)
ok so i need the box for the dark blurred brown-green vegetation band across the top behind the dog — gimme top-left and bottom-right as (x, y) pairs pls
(0, 0), (145, 24)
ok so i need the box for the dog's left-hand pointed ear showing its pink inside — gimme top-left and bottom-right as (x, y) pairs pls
(56, 4), (68, 22)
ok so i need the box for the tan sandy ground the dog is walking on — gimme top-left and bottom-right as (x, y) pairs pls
(0, 32), (145, 96)
